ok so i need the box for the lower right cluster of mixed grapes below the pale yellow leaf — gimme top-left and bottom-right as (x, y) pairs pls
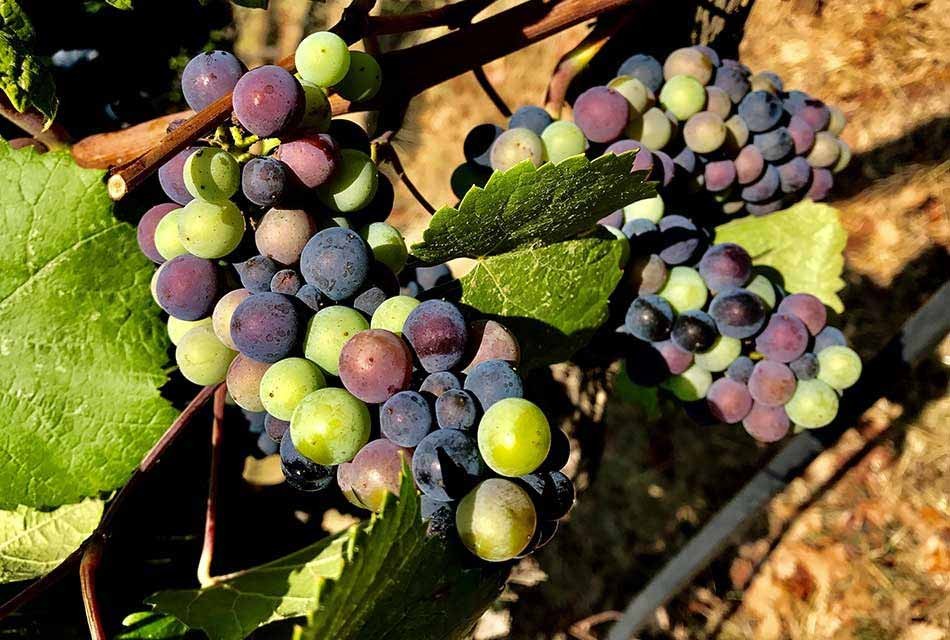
(618, 225), (861, 442)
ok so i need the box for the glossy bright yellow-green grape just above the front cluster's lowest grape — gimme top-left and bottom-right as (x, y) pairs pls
(478, 398), (551, 477)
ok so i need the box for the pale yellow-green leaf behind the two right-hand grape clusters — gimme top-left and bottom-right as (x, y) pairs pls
(716, 200), (848, 313)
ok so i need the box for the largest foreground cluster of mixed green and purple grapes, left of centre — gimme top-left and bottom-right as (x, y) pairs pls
(138, 33), (574, 561)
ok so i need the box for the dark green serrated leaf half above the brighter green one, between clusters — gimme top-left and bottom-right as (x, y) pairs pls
(412, 151), (656, 262)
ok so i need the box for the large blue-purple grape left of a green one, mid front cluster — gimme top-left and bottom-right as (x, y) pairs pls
(231, 292), (300, 362)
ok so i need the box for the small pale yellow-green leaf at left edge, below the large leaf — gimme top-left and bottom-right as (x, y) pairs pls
(0, 498), (103, 583)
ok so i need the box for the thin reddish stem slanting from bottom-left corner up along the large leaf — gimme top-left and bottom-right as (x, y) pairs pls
(0, 385), (223, 620)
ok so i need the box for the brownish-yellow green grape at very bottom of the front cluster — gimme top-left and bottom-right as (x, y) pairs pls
(455, 478), (538, 562)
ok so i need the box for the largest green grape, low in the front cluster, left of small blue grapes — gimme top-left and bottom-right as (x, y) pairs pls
(290, 387), (371, 466)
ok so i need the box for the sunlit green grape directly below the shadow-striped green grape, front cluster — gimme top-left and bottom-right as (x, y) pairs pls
(178, 198), (244, 260)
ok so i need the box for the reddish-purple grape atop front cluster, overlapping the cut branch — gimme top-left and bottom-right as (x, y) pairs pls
(232, 64), (304, 138)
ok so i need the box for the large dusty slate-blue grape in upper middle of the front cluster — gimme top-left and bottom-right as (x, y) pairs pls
(300, 227), (370, 302)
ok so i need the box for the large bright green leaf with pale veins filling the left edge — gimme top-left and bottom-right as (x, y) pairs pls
(0, 140), (175, 508)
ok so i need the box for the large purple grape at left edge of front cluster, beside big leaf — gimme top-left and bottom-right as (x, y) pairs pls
(155, 253), (221, 320)
